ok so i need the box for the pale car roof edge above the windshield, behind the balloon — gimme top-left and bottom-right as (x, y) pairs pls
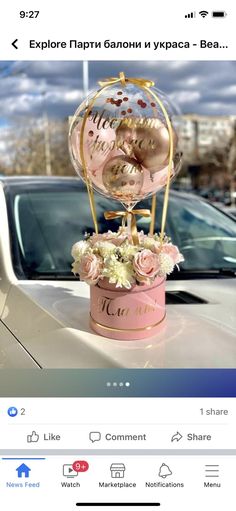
(0, 176), (203, 202)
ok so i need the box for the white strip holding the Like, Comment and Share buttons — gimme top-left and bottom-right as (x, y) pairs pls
(0, 398), (236, 450)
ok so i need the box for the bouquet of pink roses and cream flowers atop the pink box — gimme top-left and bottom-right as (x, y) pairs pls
(71, 227), (184, 289)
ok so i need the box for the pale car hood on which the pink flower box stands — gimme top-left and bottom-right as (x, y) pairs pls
(2, 279), (236, 368)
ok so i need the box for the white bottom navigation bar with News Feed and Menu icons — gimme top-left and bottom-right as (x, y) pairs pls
(0, 452), (233, 511)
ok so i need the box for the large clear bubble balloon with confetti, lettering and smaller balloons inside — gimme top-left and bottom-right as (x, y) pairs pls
(69, 83), (181, 209)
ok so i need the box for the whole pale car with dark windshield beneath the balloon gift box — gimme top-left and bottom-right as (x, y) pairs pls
(0, 177), (236, 368)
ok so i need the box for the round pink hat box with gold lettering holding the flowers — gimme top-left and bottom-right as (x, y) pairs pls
(90, 277), (166, 341)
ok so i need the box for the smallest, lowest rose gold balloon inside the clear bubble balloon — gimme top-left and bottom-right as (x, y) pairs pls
(103, 156), (144, 205)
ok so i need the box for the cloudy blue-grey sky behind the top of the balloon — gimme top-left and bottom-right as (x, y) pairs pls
(0, 61), (236, 125)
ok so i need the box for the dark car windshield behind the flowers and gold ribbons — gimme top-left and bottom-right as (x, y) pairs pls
(6, 183), (236, 278)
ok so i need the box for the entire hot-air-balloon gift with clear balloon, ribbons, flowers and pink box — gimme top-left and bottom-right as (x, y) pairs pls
(69, 72), (184, 340)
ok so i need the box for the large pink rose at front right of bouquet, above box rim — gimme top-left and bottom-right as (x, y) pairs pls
(133, 249), (159, 284)
